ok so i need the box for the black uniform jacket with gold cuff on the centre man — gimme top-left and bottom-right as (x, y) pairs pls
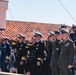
(32, 41), (45, 62)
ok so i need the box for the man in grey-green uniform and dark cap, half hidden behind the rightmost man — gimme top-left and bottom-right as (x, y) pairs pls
(51, 31), (60, 75)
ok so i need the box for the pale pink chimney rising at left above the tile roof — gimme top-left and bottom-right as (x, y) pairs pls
(0, 0), (8, 30)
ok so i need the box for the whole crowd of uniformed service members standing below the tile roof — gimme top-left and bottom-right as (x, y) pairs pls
(0, 26), (76, 75)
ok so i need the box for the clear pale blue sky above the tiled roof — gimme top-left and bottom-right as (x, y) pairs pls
(6, 0), (76, 26)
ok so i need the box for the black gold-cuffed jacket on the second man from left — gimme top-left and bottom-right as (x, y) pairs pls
(16, 42), (27, 63)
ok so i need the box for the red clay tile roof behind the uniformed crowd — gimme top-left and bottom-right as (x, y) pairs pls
(0, 20), (70, 40)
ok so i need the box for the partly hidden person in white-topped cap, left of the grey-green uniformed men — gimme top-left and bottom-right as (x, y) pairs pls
(43, 31), (55, 75)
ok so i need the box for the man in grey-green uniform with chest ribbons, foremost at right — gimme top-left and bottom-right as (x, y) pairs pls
(59, 30), (75, 75)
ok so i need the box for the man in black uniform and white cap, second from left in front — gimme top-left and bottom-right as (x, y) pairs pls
(16, 34), (27, 74)
